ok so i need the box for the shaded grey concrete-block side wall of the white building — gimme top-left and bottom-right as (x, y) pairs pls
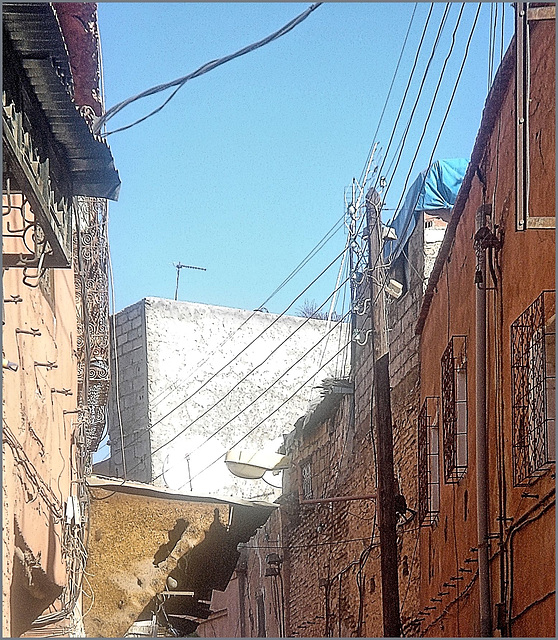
(108, 300), (151, 482)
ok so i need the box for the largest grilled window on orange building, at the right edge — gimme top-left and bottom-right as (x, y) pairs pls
(511, 291), (556, 486)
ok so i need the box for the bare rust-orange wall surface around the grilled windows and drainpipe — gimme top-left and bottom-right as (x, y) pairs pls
(417, 20), (555, 637)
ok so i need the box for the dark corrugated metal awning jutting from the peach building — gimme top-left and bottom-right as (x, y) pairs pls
(2, 2), (120, 200)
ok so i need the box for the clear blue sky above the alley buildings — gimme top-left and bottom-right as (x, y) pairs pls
(98, 2), (513, 313)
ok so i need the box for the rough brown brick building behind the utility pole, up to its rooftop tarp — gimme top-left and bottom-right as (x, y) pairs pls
(198, 162), (466, 637)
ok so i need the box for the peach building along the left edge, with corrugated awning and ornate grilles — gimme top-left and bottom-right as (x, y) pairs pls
(2, 3), (120, 637)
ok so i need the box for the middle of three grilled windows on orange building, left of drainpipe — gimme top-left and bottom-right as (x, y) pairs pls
(441, 336), (468, 483)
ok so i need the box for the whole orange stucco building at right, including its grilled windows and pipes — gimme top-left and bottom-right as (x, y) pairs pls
(417, 7), (555, 637)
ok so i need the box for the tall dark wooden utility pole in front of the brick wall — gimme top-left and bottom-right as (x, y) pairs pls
(366, 190), (401, 638)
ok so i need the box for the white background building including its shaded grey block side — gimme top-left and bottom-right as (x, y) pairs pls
(100, 298), (348, 498)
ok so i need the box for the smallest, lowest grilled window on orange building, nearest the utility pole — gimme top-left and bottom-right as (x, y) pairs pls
(418, 396), (440, 527)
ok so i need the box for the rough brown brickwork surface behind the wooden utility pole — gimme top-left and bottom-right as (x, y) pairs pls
(198, 206), (442, 637)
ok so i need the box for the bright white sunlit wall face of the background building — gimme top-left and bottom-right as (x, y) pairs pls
(111, 298), (348, 498)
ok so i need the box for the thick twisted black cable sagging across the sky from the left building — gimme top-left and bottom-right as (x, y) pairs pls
(93, 2), (323, 136)
